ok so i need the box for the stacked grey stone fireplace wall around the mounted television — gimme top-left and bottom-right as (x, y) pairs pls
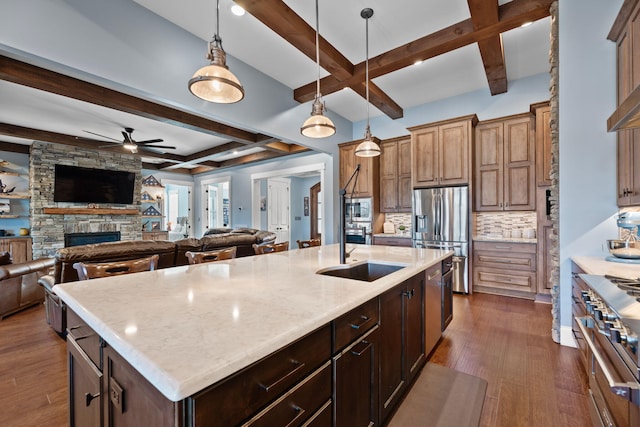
(29, 141), (142, 259)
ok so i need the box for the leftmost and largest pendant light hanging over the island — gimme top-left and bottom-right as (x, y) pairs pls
(189, 0), (244, 104)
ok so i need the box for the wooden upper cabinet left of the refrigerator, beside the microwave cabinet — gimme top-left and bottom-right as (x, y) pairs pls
(380, 136), (411, 213)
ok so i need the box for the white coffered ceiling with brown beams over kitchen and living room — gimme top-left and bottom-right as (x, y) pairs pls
(0, 0), (551, 173)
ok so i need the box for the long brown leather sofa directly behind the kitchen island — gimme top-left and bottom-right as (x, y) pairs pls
(39, 228), (276, 336)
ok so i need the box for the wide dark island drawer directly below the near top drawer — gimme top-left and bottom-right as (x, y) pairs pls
(244, 362), (331, 427)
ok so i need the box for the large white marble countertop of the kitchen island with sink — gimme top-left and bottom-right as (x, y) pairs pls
(54, 244), (452, 401)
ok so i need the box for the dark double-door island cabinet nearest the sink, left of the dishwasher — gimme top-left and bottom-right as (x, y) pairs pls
(379, 273), (424, 424)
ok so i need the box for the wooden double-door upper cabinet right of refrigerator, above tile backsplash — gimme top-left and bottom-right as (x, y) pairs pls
(474, 113), (536, 211)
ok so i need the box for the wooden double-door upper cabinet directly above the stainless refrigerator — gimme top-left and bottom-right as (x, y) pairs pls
(409, 114), (478, 188)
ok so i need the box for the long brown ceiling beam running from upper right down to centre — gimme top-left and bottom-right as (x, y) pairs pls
(293, 0), (553, 102)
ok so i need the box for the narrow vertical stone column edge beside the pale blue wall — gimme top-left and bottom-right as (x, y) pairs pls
(548, 1), (560, 343)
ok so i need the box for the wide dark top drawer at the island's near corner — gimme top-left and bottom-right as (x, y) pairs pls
(189, 324), (331, 426)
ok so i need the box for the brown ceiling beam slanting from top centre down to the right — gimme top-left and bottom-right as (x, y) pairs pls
(234, 0), (404, 119)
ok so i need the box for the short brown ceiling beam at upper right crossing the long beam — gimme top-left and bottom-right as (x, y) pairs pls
(467, 0), (507, 95)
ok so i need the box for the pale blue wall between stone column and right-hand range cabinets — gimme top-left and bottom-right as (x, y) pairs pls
(559, 0), (622, 344)
